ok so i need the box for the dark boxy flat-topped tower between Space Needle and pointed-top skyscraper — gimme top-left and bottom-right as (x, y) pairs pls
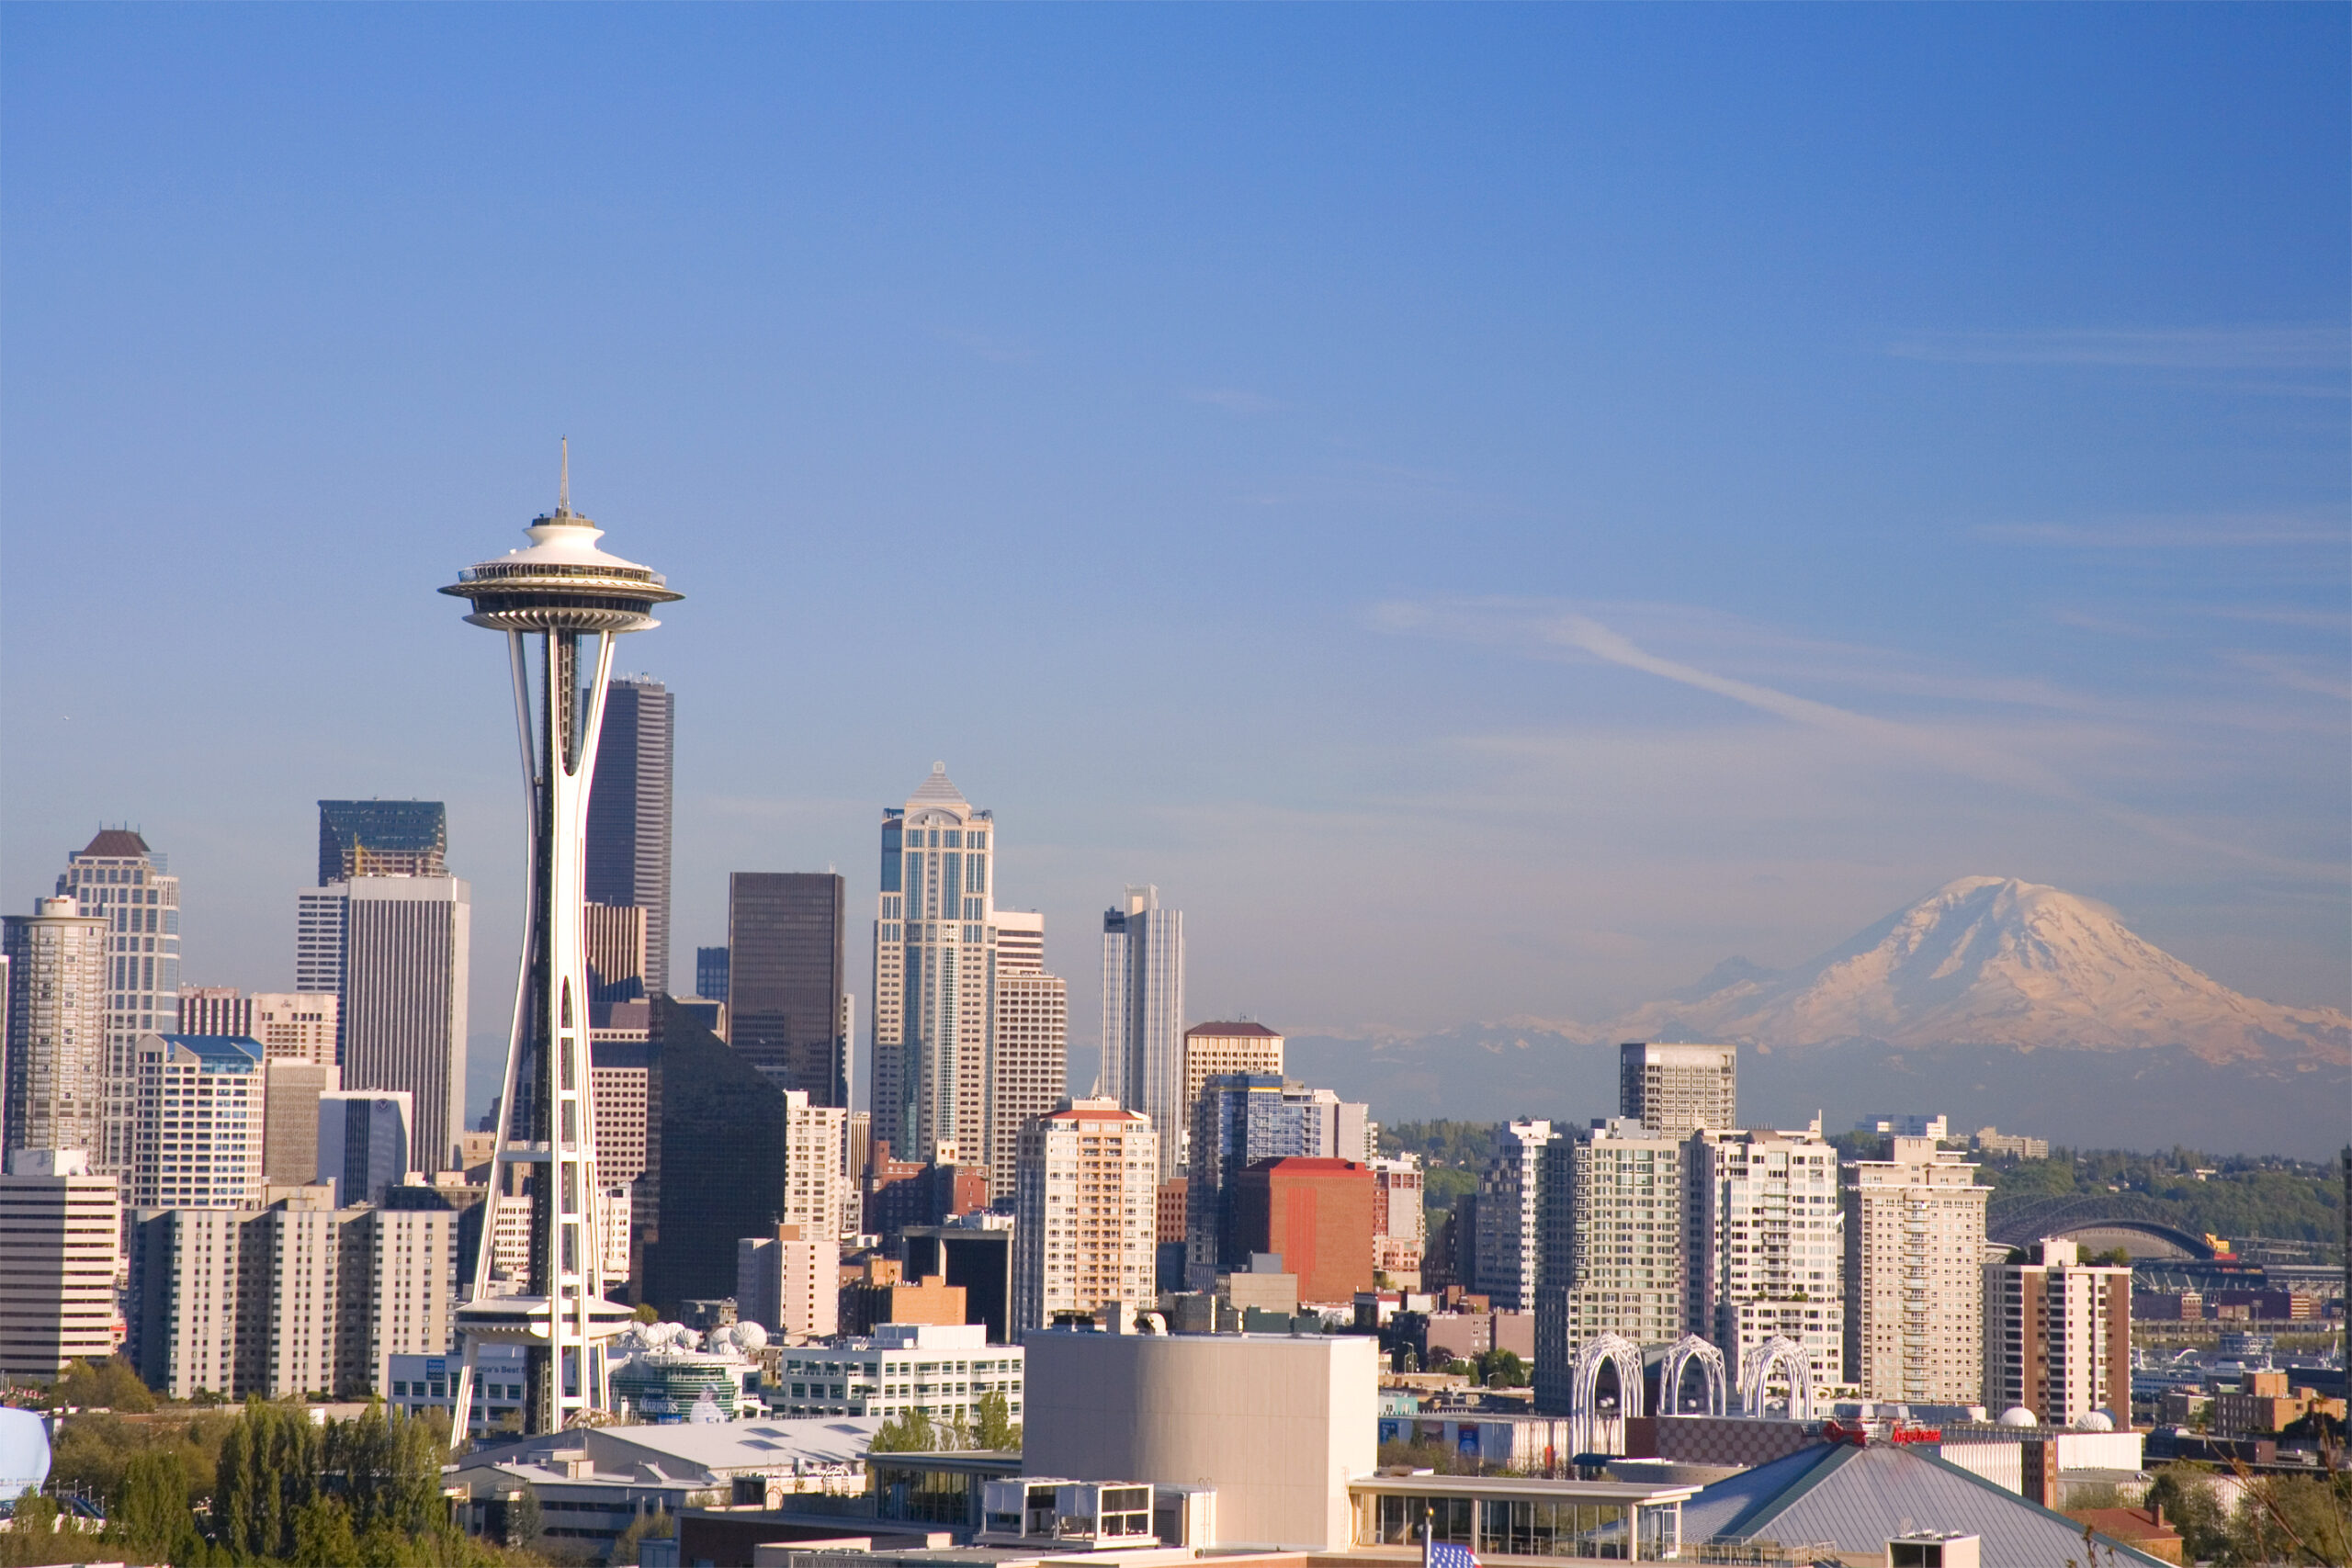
(727, 872), (849, 1107)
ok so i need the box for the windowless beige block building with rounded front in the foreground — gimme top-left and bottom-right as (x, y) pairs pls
(1021, 1331), (1381, 1551)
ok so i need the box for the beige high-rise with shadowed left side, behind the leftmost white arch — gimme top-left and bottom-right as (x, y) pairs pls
(1523, 1117), (1687, 1416)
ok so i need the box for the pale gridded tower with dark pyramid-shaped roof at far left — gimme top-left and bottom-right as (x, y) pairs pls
(56, 828), (179, 1170)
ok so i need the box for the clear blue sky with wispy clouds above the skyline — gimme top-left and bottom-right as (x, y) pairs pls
(0, 5), (2352, 1114)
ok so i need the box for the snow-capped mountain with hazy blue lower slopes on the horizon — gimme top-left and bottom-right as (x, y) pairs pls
(1289, 877), (2352, 1159)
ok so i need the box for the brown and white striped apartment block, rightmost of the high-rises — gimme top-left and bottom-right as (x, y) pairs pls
(1985, 1239), (2131, 1427)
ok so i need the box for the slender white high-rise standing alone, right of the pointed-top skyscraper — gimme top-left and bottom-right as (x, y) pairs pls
(1103, 886), (1190, 1180)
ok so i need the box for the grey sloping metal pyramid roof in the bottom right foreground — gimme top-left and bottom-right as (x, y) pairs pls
(1681, 1443), (2157, 1568)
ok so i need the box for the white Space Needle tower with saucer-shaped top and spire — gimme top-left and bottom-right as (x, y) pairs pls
(442, 445), (684, 1441)
